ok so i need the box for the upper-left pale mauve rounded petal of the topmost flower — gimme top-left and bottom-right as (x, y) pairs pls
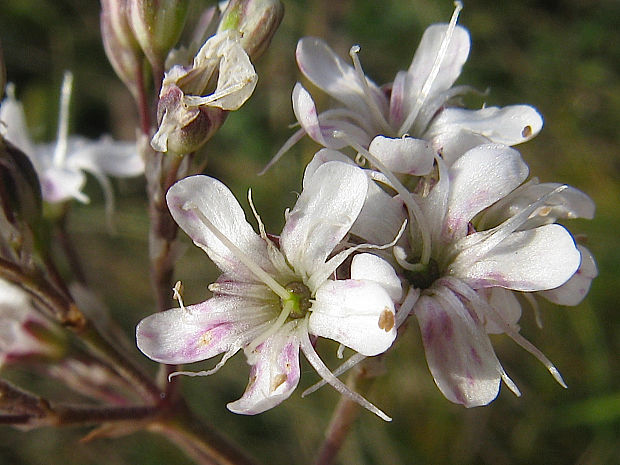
(296, 37), (387, 114)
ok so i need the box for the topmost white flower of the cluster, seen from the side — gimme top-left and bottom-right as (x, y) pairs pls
(268, 2), (543, 166)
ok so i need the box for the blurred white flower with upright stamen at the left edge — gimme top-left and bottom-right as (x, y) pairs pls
(0, 72), (144, 211)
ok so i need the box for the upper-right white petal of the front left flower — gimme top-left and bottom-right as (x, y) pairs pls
(280, 161), (368, 277)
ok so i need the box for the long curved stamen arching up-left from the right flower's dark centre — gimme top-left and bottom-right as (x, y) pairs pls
(334, 131), (431, 265)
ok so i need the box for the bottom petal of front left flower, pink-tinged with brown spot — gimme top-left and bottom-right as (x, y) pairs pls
(227, 322), (300, 415)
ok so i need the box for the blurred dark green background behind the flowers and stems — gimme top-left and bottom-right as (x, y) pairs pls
(0, 0), (620, 465)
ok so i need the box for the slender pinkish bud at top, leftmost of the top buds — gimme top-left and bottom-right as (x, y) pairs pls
(101, 0), (143, 97)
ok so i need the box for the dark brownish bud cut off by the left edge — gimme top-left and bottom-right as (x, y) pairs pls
(0, 138), (41, 226)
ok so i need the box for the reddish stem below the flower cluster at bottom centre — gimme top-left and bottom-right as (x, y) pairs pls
(315, 358), (381, 465)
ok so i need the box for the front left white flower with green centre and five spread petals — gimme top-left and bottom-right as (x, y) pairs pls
(137, 162), (401, 419)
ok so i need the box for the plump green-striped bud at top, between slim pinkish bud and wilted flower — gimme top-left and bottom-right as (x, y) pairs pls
(128, 0), (189, 69)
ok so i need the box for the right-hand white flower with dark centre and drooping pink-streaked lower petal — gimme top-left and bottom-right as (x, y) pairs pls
(353, 144), (581, 407)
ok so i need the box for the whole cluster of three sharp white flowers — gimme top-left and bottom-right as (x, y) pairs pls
(137, 4), (597, 419)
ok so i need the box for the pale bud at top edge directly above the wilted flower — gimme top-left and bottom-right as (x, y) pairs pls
(218, 0), (284, 60)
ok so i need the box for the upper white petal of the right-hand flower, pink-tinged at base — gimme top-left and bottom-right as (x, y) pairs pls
(442, 144), (529, 239)
